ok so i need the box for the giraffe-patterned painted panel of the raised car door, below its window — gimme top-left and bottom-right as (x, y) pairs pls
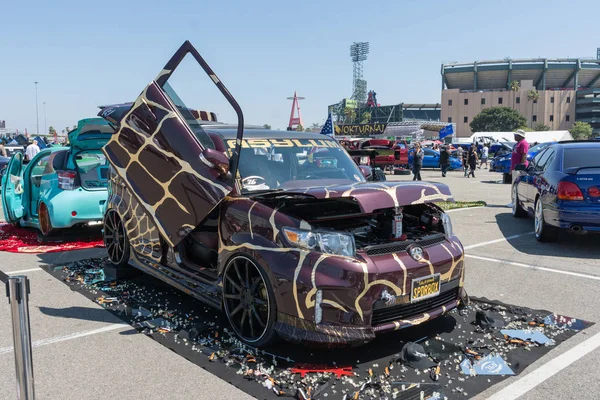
(103, 82), (232, 246)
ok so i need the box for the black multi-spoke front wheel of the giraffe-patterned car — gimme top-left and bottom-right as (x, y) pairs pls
(223, 255), (277, 347)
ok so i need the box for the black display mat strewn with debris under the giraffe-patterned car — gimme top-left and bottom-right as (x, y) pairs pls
(40, 259), (591, 399)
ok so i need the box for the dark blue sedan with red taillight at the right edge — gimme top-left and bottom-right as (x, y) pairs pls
(512, 141), (600, 241)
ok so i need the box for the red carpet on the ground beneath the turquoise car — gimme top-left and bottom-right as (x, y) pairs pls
(0, 223), (104, 253)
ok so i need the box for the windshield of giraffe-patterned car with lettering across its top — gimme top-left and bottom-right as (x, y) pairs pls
(227, 137), (365, 193)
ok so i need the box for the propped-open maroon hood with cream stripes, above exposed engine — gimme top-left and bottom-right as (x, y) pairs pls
(254, 182), (454, 213)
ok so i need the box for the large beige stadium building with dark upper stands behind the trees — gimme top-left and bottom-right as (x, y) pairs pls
(441, 58), (600, 137)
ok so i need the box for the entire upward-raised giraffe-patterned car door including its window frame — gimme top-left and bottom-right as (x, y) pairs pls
(104, 41), (244, 246)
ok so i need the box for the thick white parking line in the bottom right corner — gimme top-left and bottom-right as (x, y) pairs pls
(488, 333), (600, 400)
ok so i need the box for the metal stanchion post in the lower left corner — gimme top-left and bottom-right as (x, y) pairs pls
(0, 271), (35, 400)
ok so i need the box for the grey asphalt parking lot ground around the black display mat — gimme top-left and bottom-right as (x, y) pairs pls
(0, 170), (600, 400)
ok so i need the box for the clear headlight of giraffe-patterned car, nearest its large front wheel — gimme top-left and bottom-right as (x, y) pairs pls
(283, 228), (356, 257)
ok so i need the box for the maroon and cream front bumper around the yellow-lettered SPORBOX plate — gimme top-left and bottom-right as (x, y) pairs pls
(275, 237), (467, 344)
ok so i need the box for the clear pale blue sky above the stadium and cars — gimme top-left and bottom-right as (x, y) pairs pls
(0, 0), (600, 133)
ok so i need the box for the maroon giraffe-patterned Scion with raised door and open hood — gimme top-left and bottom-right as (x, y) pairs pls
(99, 42), (468, 346)
